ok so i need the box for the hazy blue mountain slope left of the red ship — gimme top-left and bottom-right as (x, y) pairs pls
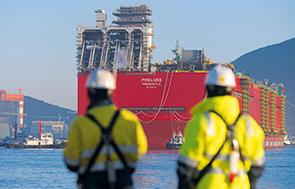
(24, 96), (77, 132)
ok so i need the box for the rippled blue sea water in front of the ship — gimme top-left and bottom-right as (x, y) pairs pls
(0, 147), (295, 189)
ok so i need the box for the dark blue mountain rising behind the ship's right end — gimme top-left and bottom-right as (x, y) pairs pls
(231, 38), (295, 135)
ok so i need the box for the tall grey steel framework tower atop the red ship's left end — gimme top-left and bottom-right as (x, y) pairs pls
(77, 5), (155, 73)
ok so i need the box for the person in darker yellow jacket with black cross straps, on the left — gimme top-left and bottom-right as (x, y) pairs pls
(64, 69), (147, 189)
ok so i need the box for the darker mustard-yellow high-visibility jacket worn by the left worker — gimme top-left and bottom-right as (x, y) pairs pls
(64, 104), (147, 174)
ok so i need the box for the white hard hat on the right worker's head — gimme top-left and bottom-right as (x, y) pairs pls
(205, 64), (237, 87)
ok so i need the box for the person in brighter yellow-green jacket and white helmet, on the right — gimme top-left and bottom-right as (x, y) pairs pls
(177, 65), (265, 189)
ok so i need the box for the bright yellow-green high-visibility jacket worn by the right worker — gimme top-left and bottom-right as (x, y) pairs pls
(178, 95), (265, 189)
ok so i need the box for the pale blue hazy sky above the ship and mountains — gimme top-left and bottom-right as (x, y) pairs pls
(0, 0), (295, 110)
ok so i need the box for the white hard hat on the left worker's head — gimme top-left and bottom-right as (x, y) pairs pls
(86, 69), (116, 90)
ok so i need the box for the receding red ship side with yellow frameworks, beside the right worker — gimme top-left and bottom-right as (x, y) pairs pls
(233, 73), (287, 147)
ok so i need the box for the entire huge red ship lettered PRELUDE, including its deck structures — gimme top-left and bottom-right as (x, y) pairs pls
(77, 5), (286, 149)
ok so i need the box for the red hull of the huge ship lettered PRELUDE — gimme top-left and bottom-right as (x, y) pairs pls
(78, 72), (283, 149)
